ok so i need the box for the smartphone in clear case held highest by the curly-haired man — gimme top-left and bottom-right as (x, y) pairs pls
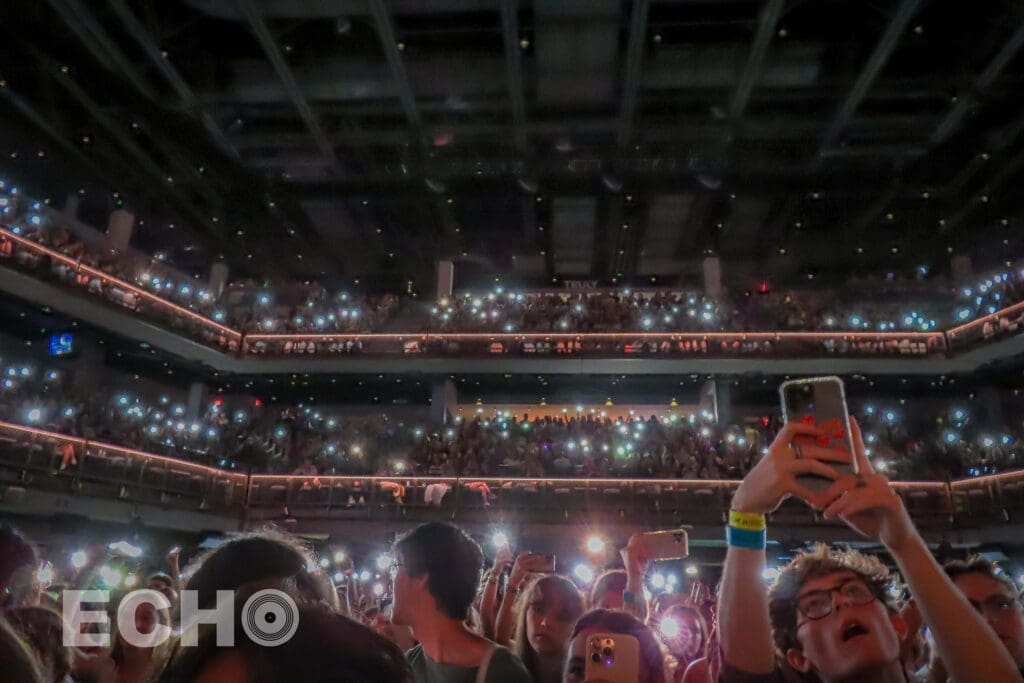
(778, 377), (857, 490)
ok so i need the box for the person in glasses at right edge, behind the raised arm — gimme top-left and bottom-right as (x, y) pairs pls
(942, 556), (1024, 675)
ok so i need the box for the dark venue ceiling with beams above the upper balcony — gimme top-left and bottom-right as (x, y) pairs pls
(0, 0), (1024, 291)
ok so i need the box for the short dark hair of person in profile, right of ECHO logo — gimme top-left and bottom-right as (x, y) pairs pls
(394, 522), (483, 621)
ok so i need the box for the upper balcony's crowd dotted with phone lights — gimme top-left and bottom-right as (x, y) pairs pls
(0, 181), (1024, 350)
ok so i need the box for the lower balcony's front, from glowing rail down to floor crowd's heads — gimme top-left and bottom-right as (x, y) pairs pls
(0, 423), (1024, 542)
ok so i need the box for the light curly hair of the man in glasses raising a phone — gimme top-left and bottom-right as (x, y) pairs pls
(768, 544), (902, 654)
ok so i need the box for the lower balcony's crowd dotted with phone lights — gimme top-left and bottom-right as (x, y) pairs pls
(0, 356), (1024, 480)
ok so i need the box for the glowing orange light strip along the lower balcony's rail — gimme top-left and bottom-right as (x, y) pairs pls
(0, 421), (999, 489)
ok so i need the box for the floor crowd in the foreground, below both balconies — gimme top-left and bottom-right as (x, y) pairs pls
(0, 422), (1024, 683)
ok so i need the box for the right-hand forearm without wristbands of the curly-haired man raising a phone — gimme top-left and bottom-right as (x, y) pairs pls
(889, 533), (1022, 683)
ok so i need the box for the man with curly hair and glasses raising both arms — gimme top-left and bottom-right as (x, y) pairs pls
(719, 420), (1024, 683)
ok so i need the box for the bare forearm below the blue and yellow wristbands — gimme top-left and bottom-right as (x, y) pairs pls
(718, 547), (775, 674)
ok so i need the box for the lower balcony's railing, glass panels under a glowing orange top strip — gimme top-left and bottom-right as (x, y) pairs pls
(0, 422), (1024, 528)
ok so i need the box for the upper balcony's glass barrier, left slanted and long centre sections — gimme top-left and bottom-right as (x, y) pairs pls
(0, 228), (958, 357)
